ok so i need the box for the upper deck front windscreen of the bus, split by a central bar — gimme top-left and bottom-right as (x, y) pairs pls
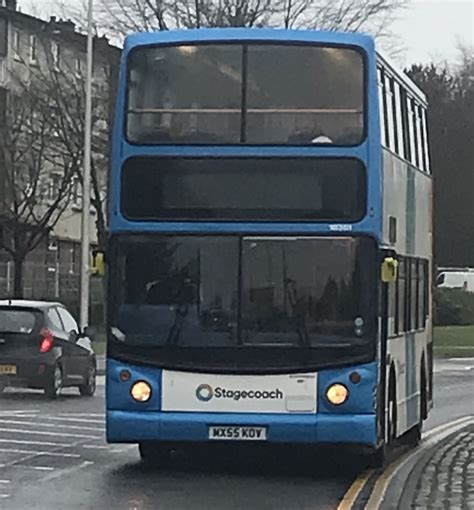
(126, 43), (364, 146)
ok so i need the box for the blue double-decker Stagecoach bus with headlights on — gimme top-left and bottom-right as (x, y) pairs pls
(107, 29), (432, 462)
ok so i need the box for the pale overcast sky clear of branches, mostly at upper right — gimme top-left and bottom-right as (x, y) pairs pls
(19, 0), (474, 65)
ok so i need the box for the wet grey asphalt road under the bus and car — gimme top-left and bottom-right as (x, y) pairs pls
(0, 362), (474, 510)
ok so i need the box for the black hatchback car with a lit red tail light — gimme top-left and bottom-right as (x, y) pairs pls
(0, 300), (96, 399)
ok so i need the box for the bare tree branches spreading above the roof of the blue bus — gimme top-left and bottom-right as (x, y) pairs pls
(58, 0), (410, 40)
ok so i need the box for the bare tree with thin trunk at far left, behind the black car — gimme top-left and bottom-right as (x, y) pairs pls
(0, 83), (73, 297)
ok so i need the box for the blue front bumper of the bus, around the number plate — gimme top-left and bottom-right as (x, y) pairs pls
(107, 410), (377, 447)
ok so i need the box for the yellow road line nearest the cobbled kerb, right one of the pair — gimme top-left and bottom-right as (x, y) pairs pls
(365, 416), (474, 510)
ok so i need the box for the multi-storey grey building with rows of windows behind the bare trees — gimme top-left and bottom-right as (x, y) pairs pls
(0, 0), (120, 314)
